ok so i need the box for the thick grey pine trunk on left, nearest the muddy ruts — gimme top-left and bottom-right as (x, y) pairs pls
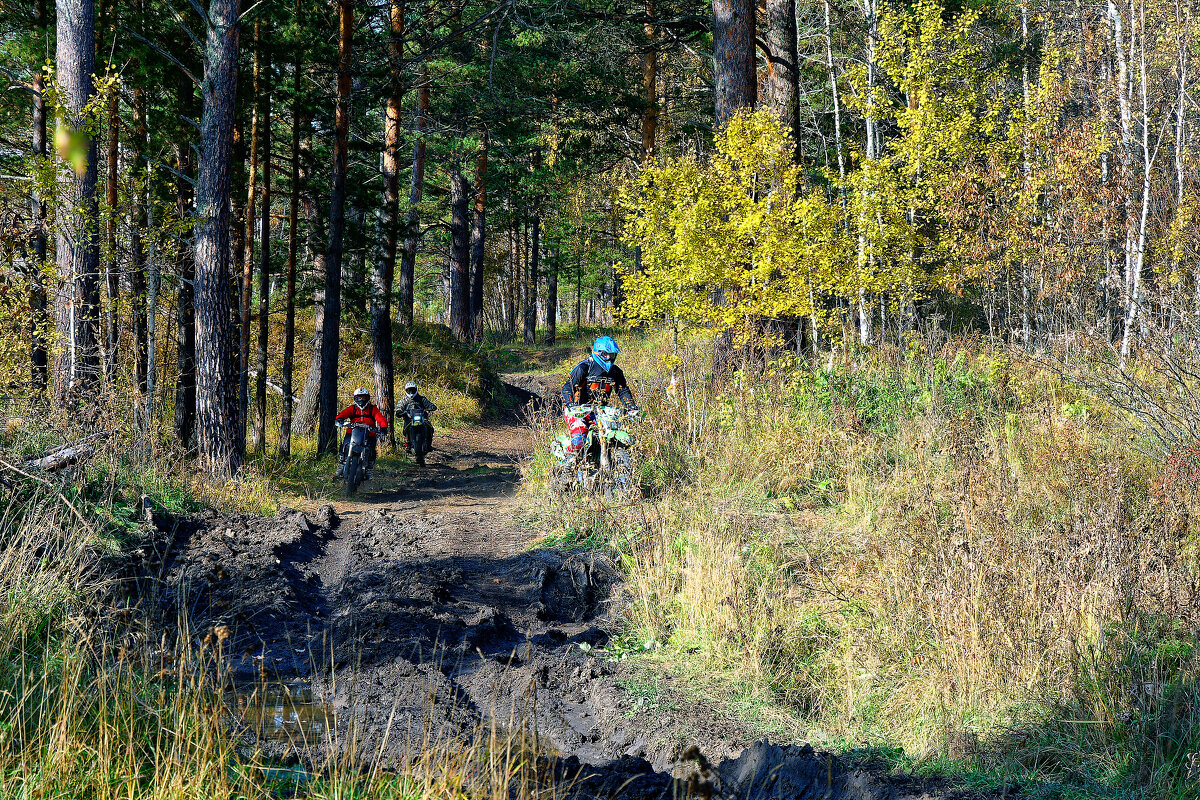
(196, 0), (241, 477)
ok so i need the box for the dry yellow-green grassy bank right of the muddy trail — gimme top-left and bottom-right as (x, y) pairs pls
(529, 328), (1200, 799)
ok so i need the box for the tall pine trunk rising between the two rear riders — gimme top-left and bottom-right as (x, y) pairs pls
(371, 0), (404, 449)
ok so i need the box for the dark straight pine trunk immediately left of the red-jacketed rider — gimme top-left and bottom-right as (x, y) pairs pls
(317, 0), (354, 453)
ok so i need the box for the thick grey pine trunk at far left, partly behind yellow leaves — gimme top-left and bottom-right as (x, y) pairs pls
(54, 0), (100, 403)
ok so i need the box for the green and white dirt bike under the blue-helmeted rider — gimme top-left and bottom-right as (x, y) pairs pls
(550, 403), (642, 501)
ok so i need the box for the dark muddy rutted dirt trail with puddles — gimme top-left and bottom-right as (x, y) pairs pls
(147, 383), (1012, 800)
